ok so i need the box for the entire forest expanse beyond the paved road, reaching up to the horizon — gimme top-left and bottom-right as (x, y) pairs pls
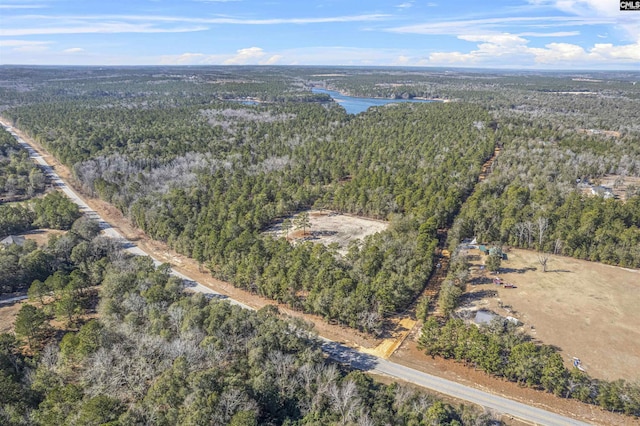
(0, 67), (640, 318)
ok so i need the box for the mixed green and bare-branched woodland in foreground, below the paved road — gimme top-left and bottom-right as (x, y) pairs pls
(0, 228), (495, 425)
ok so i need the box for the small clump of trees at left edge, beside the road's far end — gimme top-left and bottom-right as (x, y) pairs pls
(0, 128), (46, 202)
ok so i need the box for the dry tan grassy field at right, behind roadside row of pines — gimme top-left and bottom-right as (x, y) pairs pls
(463, 249), (640, 381)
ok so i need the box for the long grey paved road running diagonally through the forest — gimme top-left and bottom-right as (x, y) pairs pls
(0, 121), (587, 426)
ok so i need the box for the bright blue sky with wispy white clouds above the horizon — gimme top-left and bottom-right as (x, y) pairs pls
(0, 0), (640, 70)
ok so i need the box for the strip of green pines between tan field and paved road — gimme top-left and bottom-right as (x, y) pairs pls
(418, 317), (640, 416)
